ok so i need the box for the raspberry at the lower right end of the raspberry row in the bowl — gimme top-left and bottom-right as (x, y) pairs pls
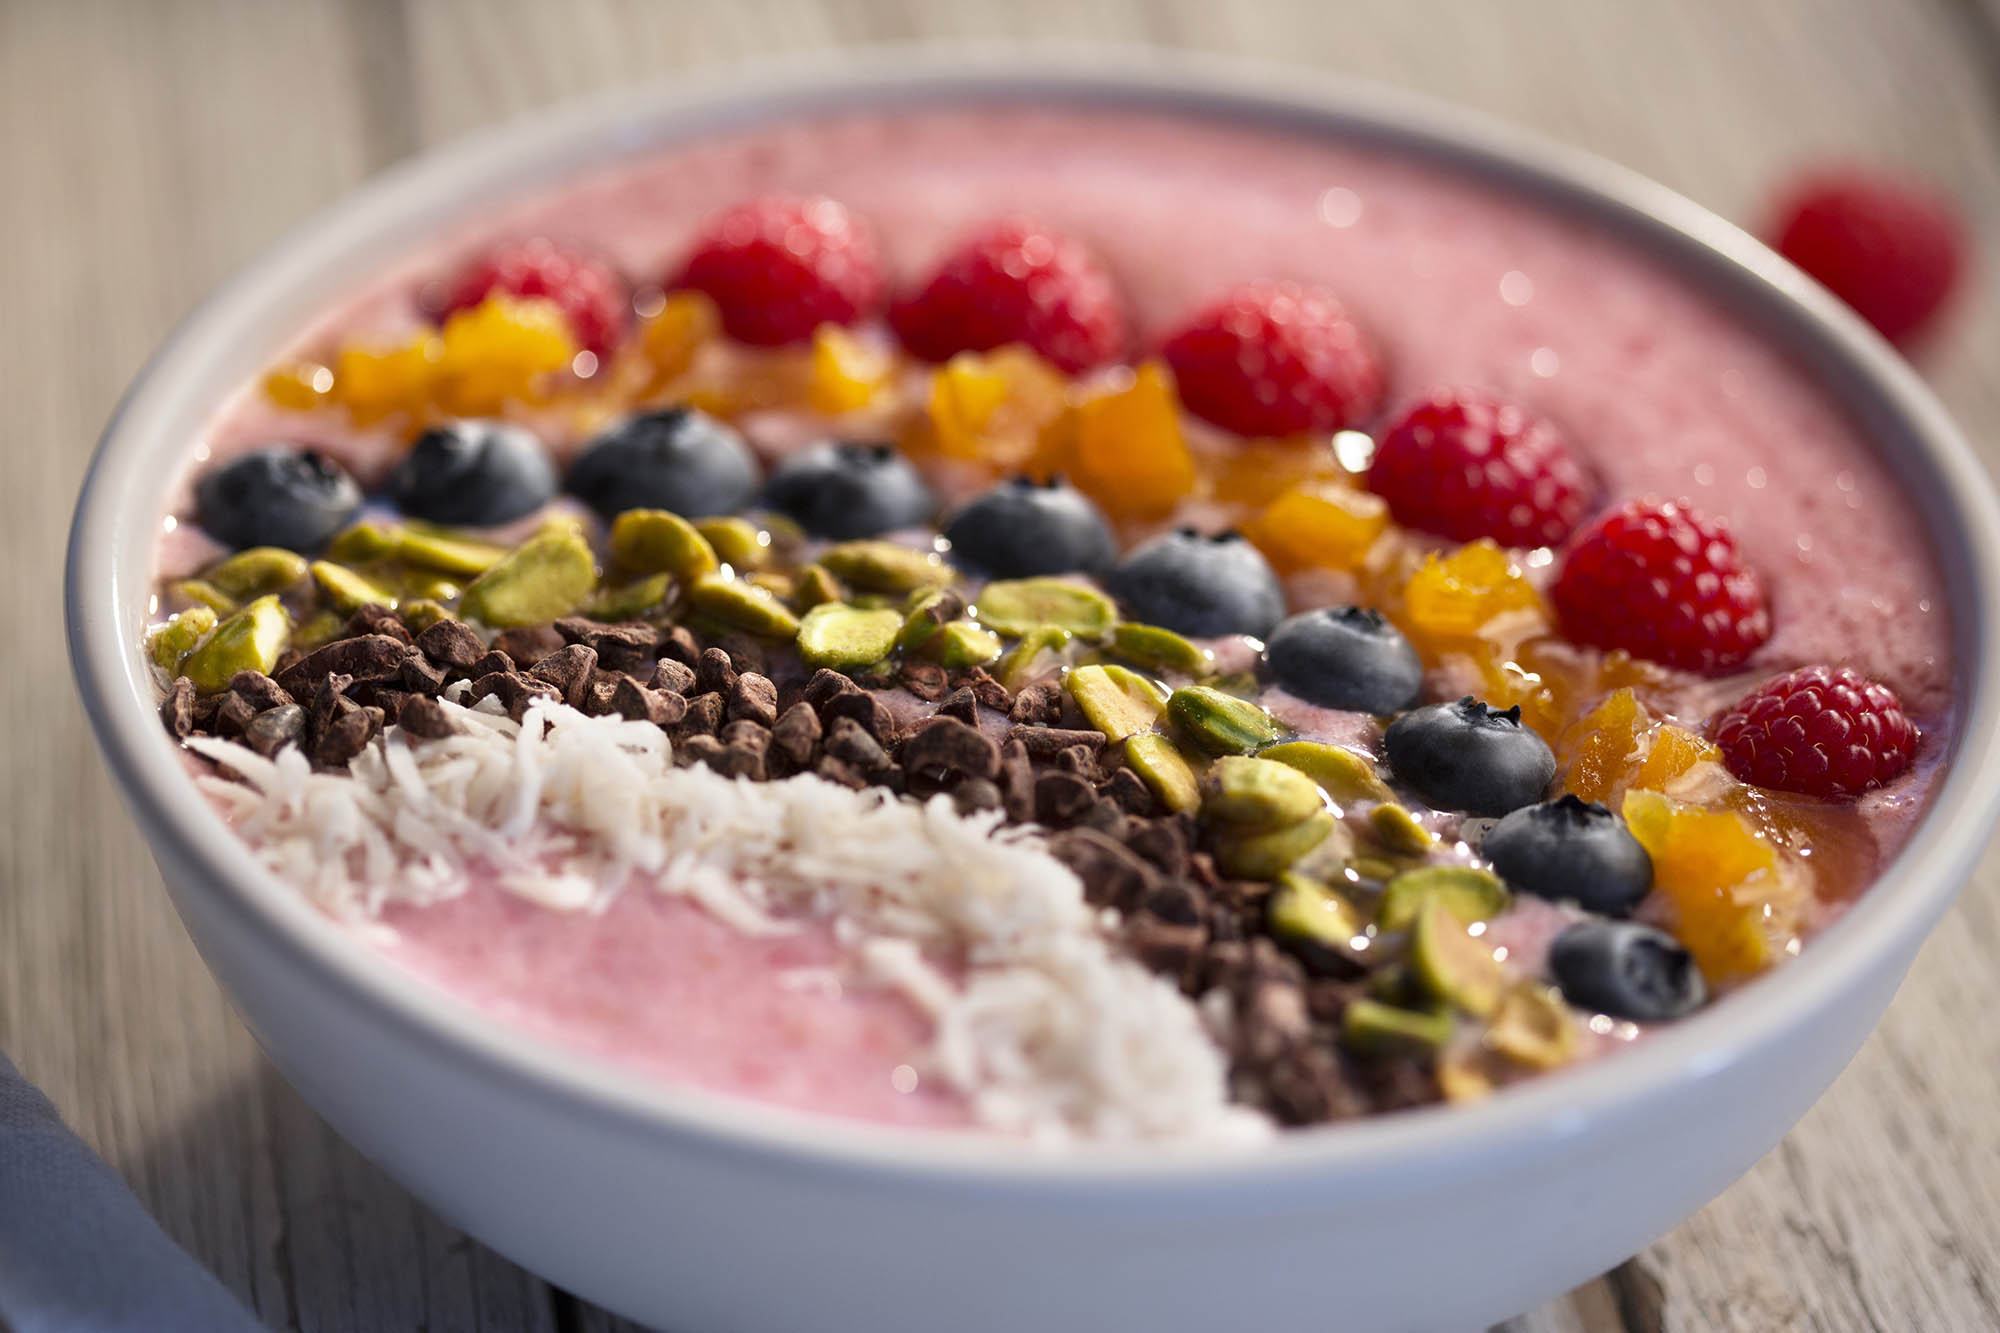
(1716, 667), (1916, 799)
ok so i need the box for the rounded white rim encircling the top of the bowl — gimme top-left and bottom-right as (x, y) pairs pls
(64, 44), (2000, 1201)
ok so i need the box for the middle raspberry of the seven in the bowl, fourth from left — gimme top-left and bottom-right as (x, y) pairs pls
(1162, 282), (1382, 436)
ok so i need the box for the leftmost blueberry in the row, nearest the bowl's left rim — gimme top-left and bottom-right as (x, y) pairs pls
(194, 444), (362, 550)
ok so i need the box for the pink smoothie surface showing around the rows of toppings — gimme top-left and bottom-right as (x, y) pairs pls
(180, 110), (1950, 1121)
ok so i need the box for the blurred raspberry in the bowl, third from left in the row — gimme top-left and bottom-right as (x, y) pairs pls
(888, 222), (1126, 374)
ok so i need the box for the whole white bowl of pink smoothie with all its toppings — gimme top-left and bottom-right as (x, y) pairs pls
(70, 46), (1996, 1329)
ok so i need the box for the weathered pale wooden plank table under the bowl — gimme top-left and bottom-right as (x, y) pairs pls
(0, 0), (2000, 1333)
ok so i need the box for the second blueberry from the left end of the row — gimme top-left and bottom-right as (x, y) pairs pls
(390, 420), (556, 528)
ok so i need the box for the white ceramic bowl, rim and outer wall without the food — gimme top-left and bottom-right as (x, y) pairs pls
(68, 52), (2000, 1333)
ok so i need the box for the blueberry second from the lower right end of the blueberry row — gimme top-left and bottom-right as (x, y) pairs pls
(1482, 797), (1652, 917)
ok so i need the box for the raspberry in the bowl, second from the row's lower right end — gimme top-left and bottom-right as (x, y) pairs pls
(1550, 500), (1770, 673)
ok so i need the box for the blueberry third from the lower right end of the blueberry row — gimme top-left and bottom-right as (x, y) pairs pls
(1384, 695), (1556, 815)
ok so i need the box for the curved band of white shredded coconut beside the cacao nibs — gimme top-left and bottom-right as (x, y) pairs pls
(186, 691), (1268, 1143)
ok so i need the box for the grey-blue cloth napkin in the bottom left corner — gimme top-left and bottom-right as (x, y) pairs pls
(0, 1055), (262, 1333)
